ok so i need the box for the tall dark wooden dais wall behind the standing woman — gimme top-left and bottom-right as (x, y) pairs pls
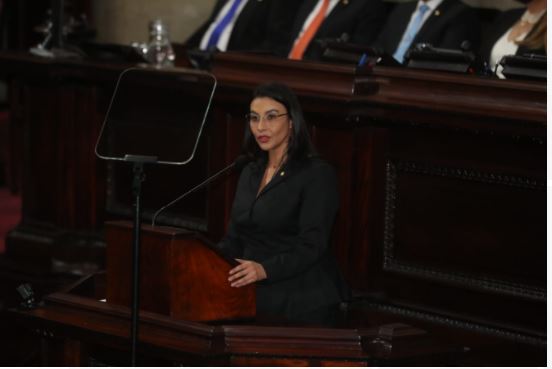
(0, 49), (546, 365)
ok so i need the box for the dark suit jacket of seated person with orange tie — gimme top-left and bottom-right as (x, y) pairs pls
(286, 0), (387, 60)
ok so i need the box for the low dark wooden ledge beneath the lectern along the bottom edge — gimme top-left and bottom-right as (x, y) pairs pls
(10, 275), (474, 366)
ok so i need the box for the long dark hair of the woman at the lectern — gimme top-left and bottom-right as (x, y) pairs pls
(243, 82), (316, 159)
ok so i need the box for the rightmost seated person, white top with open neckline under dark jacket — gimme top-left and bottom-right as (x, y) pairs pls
(481, 0), (546, 77)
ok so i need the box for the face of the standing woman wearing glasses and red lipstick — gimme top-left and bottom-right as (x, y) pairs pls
(249, 97), (292, 155)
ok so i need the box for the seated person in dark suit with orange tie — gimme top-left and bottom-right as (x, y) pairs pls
(288, 0), (386, 60)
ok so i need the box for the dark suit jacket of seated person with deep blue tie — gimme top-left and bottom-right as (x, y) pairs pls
(185, 0), (303, 56)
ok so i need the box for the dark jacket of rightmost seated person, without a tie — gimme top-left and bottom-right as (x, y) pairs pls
(480, 8), (546, 62)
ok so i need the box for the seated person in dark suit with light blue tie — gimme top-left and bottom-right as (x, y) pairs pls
(374, 0), (479, 63)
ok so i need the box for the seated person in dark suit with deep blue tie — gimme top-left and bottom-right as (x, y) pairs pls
(185, 0), (302, 56)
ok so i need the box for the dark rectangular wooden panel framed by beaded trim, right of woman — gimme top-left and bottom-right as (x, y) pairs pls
(383, 161), (546, 301)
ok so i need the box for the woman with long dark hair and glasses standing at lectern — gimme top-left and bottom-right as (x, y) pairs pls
(219, 83), (347, 323)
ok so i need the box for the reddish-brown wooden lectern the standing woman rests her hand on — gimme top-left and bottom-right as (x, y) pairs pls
(106, 222), (255, 321)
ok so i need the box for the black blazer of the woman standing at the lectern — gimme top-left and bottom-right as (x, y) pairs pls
(219, 158), (346, 320)
